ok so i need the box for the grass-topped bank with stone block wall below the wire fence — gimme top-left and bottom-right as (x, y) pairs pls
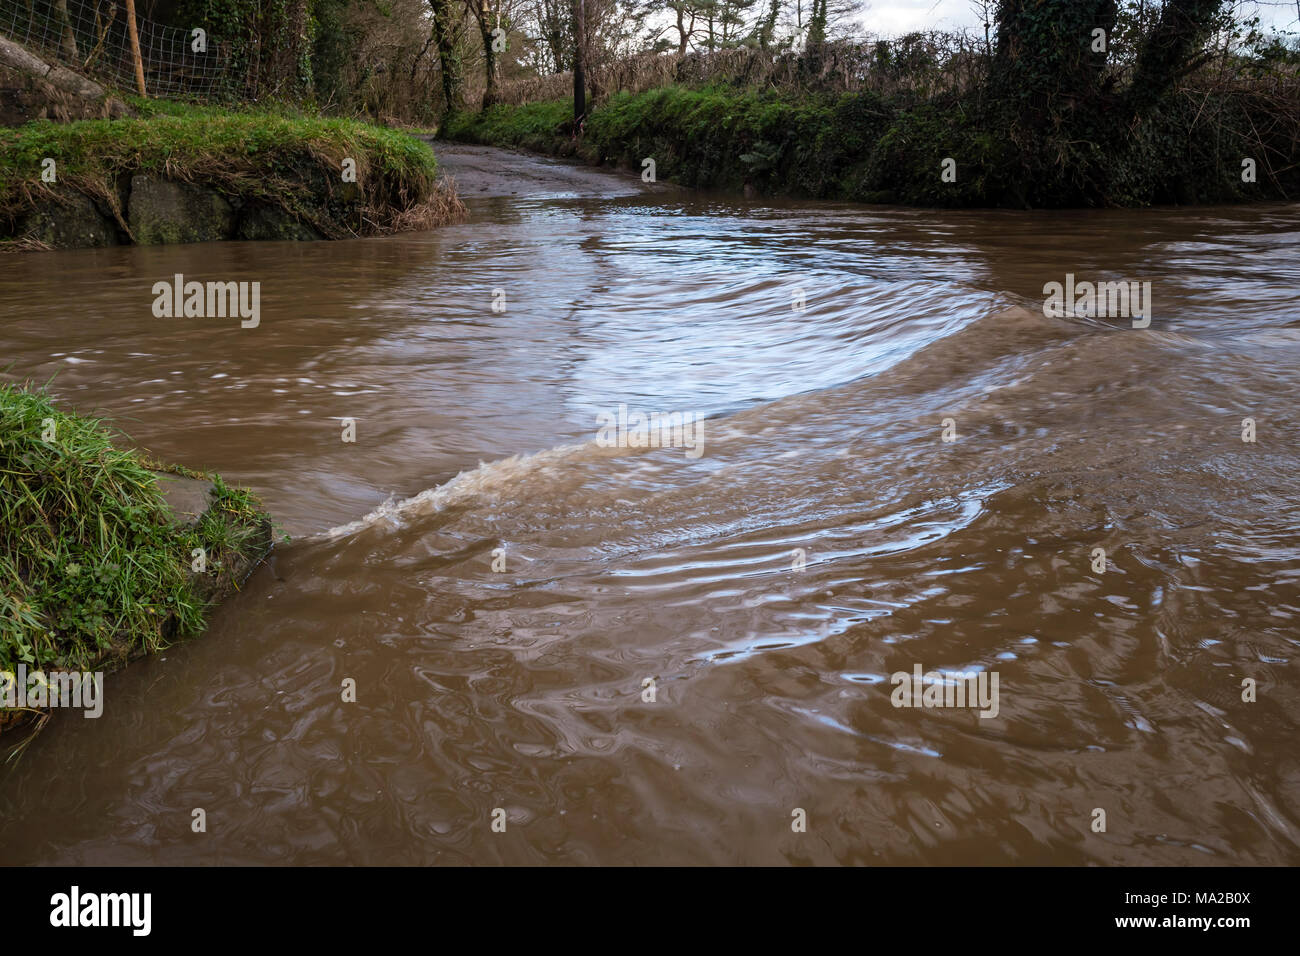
(0, 100), (463, 251)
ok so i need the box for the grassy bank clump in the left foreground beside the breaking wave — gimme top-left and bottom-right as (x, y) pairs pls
(0, 385), (269, 686)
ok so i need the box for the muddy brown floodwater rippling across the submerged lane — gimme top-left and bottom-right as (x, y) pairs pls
(0, 147), (1300, 864)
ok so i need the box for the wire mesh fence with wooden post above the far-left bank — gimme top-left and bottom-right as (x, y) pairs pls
(0, 0), (243, 99)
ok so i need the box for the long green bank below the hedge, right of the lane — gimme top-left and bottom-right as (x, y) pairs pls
(442, 85), (1300, 207)
